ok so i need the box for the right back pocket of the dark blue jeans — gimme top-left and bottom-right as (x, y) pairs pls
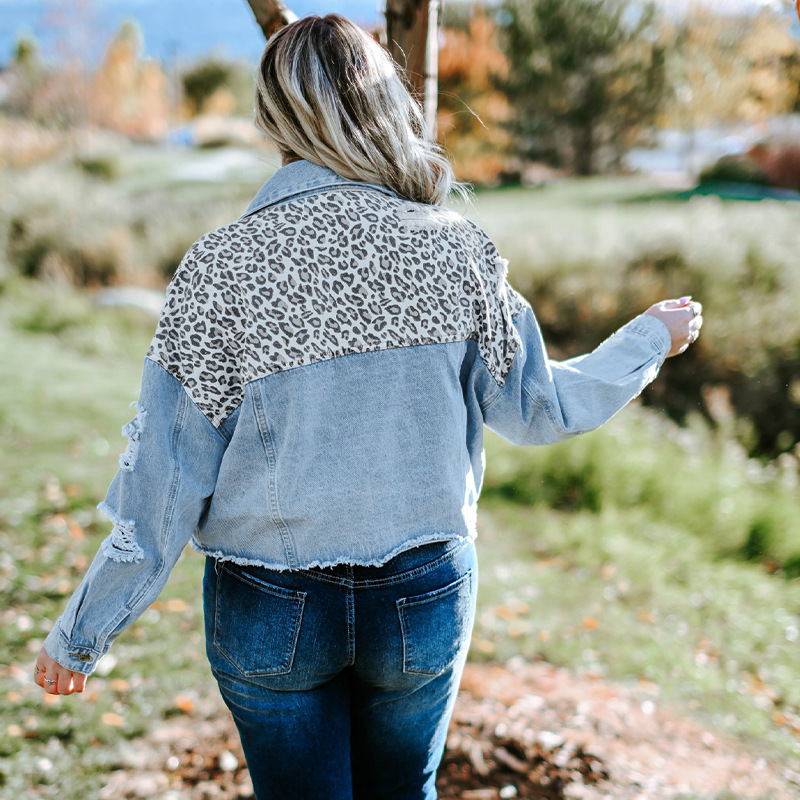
(396, 571), (472, 675)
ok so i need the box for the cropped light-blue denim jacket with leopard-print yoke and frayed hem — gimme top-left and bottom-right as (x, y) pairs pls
(45, 161), (670, 673)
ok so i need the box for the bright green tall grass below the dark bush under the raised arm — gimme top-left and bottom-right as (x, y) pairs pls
(482, 407), (800, 577)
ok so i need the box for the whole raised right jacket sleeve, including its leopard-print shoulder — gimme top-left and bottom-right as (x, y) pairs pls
(470, 231), (671, 444)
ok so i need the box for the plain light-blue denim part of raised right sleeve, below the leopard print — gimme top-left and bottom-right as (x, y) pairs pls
(474, 305), (670, 445)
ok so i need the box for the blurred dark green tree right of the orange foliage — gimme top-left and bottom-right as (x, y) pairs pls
(500, 0), (665, 175)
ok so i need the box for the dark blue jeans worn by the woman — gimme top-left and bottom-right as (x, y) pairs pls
(204, 541), (477, 800)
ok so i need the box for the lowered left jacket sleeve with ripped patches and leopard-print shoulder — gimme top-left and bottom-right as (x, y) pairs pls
(44, 246), (236, 674)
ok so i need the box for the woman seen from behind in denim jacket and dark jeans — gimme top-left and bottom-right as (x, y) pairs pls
(35, 15), (702, 800)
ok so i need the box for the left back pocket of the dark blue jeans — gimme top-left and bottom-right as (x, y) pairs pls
(214, 564), (306, 677)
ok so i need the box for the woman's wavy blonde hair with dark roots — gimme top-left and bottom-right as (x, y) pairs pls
(256, 14), (464, 205)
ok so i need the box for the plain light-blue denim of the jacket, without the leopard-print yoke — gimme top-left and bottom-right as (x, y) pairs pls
(45, 162), (670, 673)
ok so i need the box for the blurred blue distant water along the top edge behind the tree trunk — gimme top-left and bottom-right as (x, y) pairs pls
(0, 0), (380, 65)
